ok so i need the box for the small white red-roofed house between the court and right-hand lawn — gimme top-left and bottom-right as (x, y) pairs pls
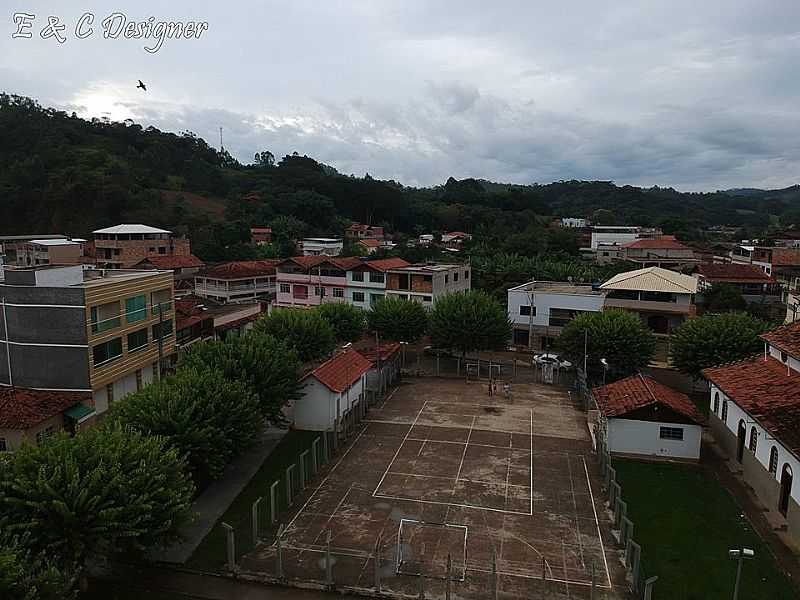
(592, 374), (704, 461)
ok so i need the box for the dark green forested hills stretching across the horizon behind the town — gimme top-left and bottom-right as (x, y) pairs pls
(0, 95), (800, 259)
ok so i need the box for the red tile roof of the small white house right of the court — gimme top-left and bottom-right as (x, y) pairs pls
(592, 374), (705, 424)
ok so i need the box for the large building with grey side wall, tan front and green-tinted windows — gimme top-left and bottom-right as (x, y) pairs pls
(0, 266), (175, 424)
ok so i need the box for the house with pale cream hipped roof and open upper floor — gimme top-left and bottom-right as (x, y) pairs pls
(600, 267), (697, 334)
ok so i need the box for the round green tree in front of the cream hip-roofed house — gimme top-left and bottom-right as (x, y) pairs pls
(556, 310), (656, 380)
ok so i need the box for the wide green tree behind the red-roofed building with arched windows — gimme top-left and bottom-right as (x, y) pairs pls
(670, 312), (767, 378)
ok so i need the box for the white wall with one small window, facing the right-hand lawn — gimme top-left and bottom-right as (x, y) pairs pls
(608, 418), (703, 459)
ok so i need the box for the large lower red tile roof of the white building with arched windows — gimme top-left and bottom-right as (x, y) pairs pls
(703, 356), (800, 457)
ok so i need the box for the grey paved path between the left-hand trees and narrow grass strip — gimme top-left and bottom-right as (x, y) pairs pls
(151, 428), (287, 564)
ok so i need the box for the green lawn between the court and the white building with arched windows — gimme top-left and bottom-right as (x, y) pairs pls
(614, 459), (798, 600)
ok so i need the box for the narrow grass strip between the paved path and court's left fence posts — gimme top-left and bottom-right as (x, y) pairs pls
(186, 430), (322, 571)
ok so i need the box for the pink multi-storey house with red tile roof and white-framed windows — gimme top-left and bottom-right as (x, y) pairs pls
(275, 256), (362, 307)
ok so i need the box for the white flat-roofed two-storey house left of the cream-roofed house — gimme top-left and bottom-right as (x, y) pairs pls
(508, 281), (605, 350)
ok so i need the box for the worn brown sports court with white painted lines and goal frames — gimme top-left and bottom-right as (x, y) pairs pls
(242, 380), (624, 598)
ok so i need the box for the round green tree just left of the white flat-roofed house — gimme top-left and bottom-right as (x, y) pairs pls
(429, 290), (511, 354)
